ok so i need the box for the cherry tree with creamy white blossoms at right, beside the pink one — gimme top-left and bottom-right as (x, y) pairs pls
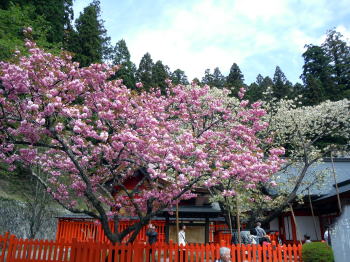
(255, 98), (350, 223)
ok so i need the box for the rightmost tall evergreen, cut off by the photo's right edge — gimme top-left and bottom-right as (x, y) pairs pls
(322, 29), (350, 100)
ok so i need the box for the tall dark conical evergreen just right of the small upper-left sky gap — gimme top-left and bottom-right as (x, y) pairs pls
(69, 0), (110, 67)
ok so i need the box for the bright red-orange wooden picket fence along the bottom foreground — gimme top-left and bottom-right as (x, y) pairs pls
(0, 234), (302, 262)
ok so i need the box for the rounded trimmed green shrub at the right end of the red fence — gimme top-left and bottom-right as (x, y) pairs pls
(302, 242), (334, 262)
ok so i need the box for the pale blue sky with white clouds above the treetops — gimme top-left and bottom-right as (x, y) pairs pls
(73, 0), (350, 84)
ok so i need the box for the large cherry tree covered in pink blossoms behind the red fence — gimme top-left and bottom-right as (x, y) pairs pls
(0, 41), (283, 243)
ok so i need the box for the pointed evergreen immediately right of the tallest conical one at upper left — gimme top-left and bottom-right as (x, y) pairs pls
(112, 39), (136, 88)
